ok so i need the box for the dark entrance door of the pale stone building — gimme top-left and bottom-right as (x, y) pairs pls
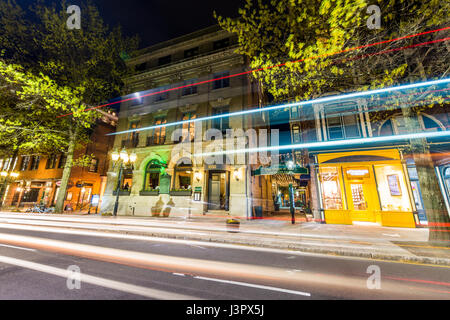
(208, 172), (228, 210)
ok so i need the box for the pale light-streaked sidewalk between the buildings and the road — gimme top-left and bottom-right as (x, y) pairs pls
(0, 213), (450, 266)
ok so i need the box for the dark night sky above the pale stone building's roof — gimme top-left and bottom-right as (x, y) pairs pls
(16, 0), (245, 48)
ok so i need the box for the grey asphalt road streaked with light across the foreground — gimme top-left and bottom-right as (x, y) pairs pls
(0, 218), (450, 300)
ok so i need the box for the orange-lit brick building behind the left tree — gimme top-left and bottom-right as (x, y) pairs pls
(0, 111), (117, 212)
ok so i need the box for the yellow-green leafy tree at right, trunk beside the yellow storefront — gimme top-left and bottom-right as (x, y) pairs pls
(215, 0), (450, 241)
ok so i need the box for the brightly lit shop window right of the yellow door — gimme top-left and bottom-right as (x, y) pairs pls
(374, 164), (412, 212)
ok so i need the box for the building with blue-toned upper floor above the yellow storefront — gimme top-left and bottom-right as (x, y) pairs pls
(284, 99), (450, 227)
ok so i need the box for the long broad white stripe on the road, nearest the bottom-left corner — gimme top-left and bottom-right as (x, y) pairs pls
(0, 256), (198, 300)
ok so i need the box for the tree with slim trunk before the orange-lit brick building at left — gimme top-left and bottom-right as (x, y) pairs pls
(0, 0), (137, 212)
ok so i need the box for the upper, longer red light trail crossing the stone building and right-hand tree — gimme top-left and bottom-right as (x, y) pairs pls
(57, 27), (450, 118)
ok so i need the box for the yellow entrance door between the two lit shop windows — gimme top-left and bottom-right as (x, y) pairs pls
(344, 166), (379, 222)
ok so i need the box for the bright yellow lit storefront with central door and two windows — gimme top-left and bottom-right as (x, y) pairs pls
(317, 149), (416, 228)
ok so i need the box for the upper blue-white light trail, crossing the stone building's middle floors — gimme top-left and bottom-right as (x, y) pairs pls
(108, 78), (450, 136)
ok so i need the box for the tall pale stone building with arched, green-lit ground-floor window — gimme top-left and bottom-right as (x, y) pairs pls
(101, 26), (259, 217)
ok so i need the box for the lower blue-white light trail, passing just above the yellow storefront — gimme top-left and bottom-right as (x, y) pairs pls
(193, 131), (450, 157)
